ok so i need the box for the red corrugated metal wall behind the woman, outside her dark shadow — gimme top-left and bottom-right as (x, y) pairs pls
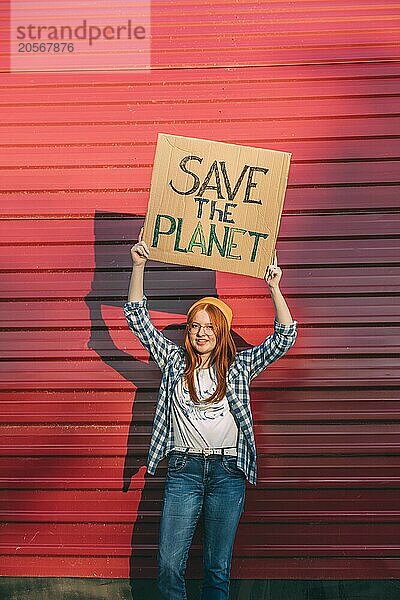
(0, 0), (400, 579)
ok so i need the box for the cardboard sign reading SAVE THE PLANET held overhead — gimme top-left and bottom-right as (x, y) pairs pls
(143, 133), (291, 278)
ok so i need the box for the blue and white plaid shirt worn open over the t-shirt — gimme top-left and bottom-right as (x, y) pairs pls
(124, 296), (297, 485)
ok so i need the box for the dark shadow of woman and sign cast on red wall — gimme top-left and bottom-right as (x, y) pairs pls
(86, 213), (248, 600)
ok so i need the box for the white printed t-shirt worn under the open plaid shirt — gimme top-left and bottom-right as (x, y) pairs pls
(172, 366), (238, 448)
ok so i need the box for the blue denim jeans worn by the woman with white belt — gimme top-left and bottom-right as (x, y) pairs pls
(158, 451), (246, 600)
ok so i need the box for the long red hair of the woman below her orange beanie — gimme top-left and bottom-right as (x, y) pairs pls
(183, 302), (236, 404)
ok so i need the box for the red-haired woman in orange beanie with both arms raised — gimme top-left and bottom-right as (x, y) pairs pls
(124, 231), (297, 600)
